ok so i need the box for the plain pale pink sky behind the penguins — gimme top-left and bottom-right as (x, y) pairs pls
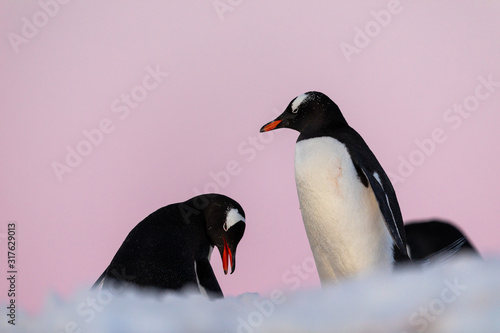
(0, 0), (500, 311)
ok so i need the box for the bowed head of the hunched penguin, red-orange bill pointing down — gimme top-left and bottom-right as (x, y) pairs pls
(204, 194), (245, 274)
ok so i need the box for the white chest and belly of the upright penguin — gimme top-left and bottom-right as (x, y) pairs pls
(295, 137), (393, 284)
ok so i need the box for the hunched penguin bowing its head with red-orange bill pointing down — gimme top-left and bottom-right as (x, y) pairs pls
(93, 194), (245, 298)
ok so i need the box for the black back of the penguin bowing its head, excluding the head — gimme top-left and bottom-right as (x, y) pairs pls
(98, 205), (209, 289)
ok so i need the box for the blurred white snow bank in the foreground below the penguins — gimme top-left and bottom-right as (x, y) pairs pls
(0, 258), (500, 333)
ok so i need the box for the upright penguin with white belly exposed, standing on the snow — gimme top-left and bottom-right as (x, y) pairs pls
(260, 91), (409, 284)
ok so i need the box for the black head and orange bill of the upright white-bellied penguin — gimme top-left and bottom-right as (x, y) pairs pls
(260, 91), (347, 133)
